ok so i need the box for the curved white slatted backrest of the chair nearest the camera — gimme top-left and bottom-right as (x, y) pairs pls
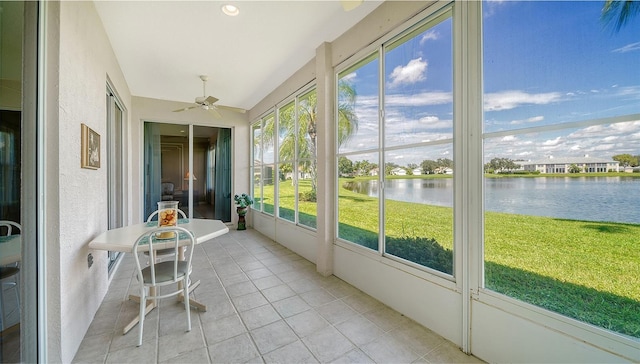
(133, 226), (196, 286)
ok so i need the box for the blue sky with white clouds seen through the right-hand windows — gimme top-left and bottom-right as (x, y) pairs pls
(340, 1), (640, 165)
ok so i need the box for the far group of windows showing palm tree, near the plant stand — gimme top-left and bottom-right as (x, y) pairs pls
(252, 88), (318, 229)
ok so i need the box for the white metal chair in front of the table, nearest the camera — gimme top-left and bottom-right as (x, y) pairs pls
(133, 226), (196, 346)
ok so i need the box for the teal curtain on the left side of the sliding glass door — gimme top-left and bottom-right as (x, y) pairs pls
(143, 122), (162, 219)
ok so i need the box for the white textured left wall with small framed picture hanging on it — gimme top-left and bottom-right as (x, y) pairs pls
(45, 2), (131, 362)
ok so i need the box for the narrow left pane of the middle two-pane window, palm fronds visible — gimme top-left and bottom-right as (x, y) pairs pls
(337, 53), (380, 251)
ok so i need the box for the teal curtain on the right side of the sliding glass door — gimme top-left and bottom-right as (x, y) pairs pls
(214, 129), (231, 222)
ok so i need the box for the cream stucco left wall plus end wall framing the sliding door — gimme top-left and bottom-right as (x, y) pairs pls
(50, 2), (249, 362)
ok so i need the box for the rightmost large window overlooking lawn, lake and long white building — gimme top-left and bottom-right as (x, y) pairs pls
(483, 1), (640, 338)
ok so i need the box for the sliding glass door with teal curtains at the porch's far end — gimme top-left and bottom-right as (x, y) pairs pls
(144, 122), (231, 222)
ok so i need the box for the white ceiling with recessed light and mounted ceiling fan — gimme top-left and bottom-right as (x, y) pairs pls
(95, 0), (381, 109)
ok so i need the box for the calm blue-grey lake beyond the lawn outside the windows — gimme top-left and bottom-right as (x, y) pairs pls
(347, 177), (640, 224)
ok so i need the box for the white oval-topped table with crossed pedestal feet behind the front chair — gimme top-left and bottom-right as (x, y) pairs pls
(89, 219), (229, 334)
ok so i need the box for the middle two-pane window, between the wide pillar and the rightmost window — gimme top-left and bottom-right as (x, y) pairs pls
(337, 6), (454, 275)
